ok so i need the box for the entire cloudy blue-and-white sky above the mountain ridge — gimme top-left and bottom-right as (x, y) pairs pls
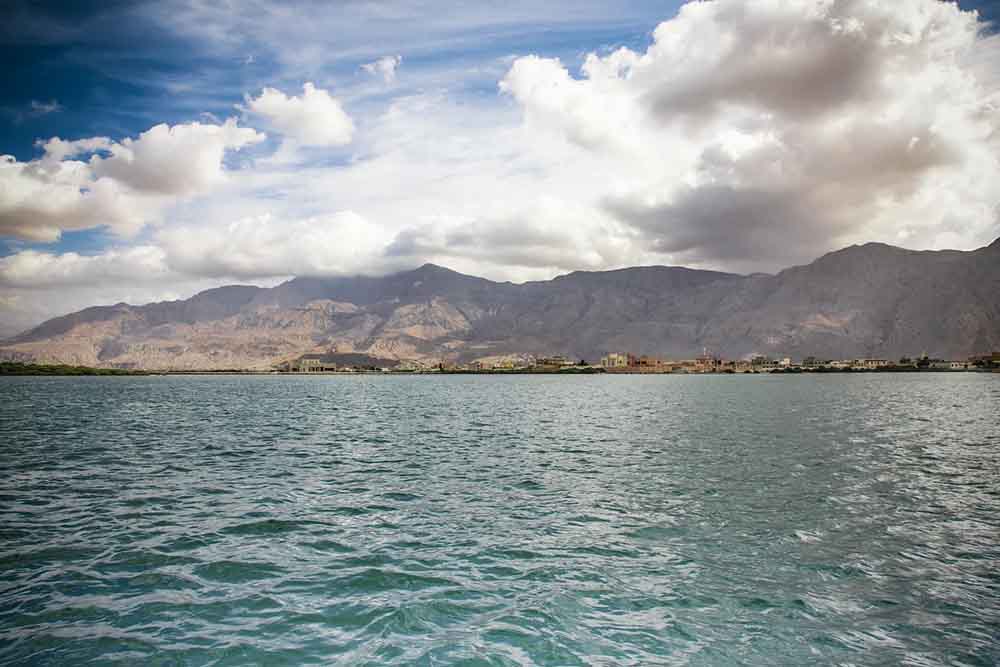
(0, 0), (1000, 336)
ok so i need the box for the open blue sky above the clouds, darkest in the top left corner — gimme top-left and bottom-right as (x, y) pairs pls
(0, 0), (679, 255)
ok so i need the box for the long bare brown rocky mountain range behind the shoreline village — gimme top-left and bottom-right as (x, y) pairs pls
(0, 240), (1000, 369)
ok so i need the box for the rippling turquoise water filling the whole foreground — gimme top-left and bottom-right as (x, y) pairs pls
(0, 373), (1000, 666)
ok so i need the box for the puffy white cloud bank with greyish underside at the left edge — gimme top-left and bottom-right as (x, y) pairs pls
(0, 120), (264, 242)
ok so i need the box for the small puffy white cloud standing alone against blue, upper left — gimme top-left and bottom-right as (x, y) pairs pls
(246, 83), (354, 146)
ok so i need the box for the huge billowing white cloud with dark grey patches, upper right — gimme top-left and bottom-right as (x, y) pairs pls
(500, 0), (1000, 270)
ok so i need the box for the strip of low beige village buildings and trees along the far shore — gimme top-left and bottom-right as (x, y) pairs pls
(274, 351), (1000, 374)
